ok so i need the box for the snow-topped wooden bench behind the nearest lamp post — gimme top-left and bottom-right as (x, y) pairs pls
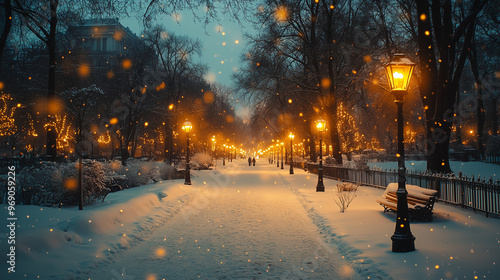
(377, 183), (437, 222)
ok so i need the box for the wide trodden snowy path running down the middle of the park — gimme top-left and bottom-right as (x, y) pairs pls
(88, 162), (361, 280)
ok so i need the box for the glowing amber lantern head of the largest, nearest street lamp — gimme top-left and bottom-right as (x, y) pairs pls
(385, 53), (415, 91)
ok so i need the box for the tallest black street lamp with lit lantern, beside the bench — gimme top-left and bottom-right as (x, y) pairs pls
(385, 54), (415, 252)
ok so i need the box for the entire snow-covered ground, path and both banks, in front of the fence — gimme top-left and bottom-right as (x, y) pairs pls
(0, 160), (500, 280)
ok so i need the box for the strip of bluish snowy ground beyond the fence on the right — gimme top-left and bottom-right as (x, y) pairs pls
(368, 160), (500, 181)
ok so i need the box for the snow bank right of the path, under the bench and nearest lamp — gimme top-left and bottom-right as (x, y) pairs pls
(293, 171), (500, 280)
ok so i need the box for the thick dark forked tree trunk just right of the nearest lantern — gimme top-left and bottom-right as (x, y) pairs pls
(416, 0), (480, 173)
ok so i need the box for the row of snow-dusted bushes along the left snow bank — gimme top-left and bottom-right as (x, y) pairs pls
(12, 160), (181, 206)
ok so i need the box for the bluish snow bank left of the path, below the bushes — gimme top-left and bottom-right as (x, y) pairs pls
(0, 178), (195, 279)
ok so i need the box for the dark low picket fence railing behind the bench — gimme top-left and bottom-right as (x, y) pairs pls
(307, 163), (500, 217)
